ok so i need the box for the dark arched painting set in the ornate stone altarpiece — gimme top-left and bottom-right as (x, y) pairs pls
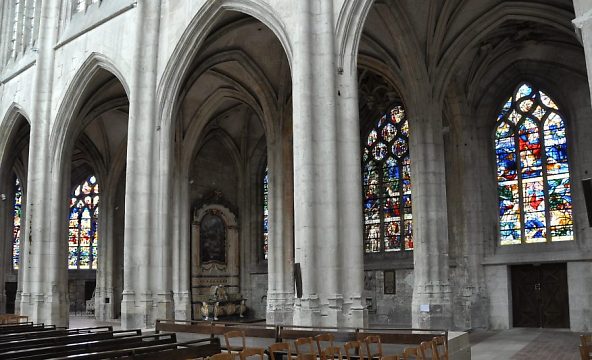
(199, 212), (226, 264)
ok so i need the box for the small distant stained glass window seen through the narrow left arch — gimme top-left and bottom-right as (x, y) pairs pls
(68, 176), (99, 269)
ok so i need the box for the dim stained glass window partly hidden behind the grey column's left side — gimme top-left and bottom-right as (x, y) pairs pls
(362, 106), (413, 253)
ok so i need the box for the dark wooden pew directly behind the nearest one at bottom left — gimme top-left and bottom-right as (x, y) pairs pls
(0, 333), (177, 360)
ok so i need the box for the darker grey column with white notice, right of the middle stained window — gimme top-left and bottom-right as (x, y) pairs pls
(408, 101), (452, 329)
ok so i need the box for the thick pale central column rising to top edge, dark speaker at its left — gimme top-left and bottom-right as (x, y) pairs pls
(292, 0), (342, 325)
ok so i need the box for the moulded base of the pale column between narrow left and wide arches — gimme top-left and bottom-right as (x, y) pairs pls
(121, 290), (154, 329)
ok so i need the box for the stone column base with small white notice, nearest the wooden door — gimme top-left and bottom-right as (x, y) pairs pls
(411, 283), (453, 329)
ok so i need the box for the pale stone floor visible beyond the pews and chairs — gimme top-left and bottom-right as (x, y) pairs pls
(70, 315), (580, 360)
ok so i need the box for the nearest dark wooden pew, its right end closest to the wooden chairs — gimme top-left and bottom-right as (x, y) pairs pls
(46, 338), (221, 360)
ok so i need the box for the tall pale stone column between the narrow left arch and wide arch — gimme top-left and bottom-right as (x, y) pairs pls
(121, 0), (167, 329)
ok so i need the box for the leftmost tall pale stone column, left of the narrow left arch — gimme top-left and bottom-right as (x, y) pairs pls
(19, 1), (68, 326)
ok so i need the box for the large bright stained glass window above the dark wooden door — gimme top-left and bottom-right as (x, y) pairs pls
(495, 83), (573, 245)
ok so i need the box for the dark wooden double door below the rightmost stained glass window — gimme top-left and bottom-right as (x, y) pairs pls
(511, 263), (569, 328)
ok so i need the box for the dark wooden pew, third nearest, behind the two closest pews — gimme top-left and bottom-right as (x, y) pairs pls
(0, 329), (142, 352)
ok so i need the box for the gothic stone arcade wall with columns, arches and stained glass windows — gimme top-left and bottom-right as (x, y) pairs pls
(0, 0), (592, 331)
